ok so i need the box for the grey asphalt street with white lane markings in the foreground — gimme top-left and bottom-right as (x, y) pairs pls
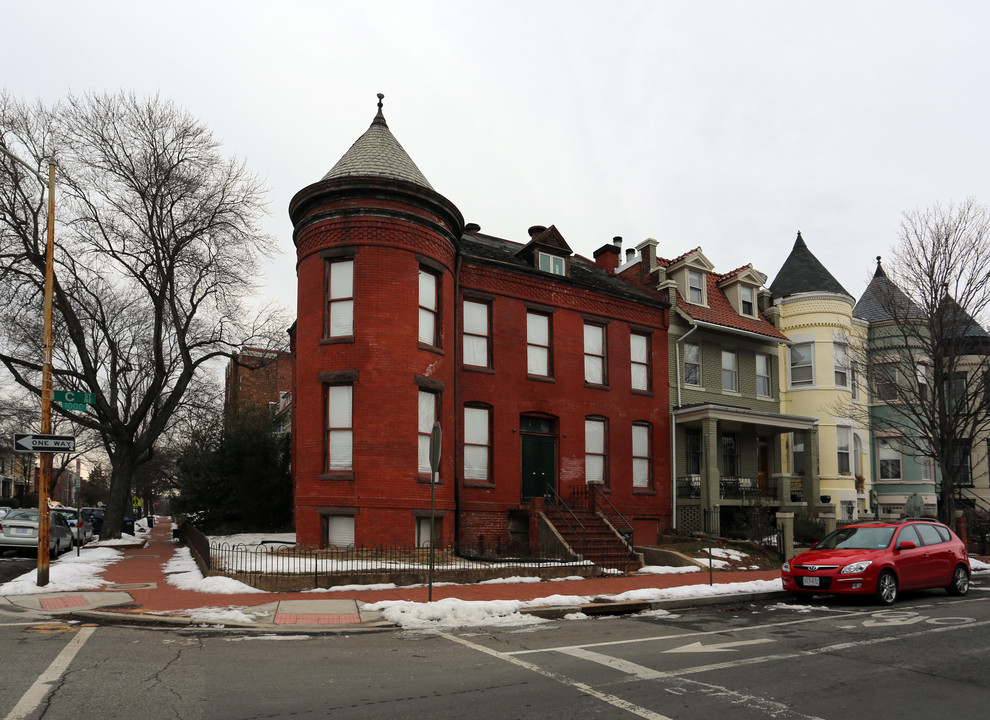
(0, 585), (990, 720)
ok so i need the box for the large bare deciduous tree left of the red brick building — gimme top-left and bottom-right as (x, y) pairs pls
(0, 94), (284, 537)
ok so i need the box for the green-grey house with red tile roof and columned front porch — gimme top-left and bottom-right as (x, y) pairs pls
(618, 239), (817, 535)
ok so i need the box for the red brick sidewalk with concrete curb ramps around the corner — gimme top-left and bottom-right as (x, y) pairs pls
(0, 518), (784, 632)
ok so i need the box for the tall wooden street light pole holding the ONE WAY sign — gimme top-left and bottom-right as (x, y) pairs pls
(0, 147), (55, 587)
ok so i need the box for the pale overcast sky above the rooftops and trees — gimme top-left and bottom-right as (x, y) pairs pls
(7, 0), (990, 316)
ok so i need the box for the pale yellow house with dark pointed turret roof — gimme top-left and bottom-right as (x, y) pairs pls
(766, 233), (872, 523)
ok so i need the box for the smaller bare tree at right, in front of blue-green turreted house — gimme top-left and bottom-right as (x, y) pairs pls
(860, 200), (990, 523)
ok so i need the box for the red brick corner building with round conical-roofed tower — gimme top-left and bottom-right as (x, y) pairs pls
(289, 96), (671, 547)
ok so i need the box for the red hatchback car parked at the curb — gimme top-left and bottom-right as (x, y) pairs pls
(781, 520), (970, 605)
